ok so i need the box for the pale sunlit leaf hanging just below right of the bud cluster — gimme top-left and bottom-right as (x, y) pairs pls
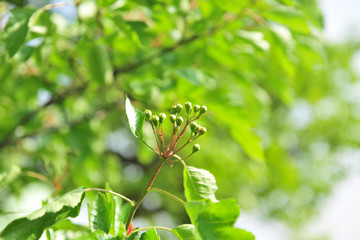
(183, 166), (218, 201)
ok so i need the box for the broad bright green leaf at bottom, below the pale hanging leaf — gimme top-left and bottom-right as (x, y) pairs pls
(185, 199), (255, 240)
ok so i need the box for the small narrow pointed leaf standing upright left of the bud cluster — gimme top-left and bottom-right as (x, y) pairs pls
(125, 97), (145, 140)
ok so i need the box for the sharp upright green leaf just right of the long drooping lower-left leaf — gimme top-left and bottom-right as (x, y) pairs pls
(88, 193), (115, 233)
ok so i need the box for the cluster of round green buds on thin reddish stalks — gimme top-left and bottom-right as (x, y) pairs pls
(144, 102), (207, 161)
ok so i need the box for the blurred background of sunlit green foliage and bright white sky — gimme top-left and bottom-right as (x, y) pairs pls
(0, 0), (360, 240)
